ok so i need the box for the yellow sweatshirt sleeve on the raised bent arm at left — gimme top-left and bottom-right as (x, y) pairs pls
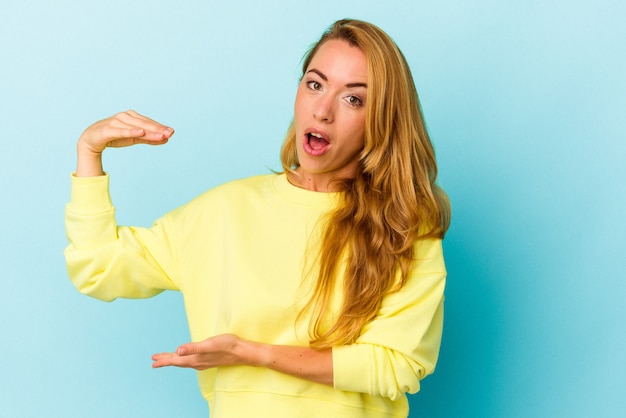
(64, 175), (178, 301)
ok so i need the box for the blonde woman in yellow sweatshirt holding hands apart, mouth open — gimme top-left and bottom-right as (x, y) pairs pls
(65, 20), (449, 418)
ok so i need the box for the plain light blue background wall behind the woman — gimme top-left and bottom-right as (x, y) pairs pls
(0, 0), (626, 417)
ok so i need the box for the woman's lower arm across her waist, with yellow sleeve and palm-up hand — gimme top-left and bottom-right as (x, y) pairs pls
(152, 239), (446, 400)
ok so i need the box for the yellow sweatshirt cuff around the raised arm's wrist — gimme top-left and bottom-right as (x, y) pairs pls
(68, 173), (113, 215)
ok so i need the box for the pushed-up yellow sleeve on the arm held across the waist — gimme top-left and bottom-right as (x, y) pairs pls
(333, 239), (446, 400)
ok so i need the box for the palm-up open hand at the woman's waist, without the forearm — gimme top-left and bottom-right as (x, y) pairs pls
(152, 334), (245, 370)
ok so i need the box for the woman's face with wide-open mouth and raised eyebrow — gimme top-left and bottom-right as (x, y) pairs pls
(291, 40), (367, 191)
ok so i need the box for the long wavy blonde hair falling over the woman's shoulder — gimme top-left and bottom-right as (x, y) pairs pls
(281, 19), (450, 348)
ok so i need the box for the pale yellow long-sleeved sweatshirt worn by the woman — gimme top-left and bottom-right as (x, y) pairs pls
(65, 174), (446, 418)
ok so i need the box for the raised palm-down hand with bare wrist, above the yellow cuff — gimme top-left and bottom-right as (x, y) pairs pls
(76, 110), (174, 177)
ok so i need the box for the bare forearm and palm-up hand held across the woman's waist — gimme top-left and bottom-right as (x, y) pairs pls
(152, 334), (333, 386)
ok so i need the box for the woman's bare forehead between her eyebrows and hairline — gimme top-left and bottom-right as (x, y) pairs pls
(307, 39), (367, 83)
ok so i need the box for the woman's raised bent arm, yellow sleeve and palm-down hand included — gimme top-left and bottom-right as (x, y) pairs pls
(65, 111), (178, 301)
